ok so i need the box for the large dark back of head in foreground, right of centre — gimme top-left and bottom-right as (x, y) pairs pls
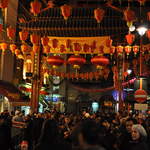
(78, 119), (99, 149)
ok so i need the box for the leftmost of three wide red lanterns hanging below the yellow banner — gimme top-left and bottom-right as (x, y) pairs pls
(47, 56), (64, 69)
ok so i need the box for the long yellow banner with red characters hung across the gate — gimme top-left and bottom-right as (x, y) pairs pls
(48, 36), (110, 54)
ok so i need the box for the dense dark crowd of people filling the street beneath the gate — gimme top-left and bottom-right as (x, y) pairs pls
(0, 110), (150, 150)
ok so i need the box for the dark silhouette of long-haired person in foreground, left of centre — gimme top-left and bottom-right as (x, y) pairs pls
(34, 120), (71, 150)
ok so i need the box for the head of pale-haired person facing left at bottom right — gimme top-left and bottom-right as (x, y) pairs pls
(132, 124), (147, 141)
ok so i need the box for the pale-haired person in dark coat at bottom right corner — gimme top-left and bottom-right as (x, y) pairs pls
(128, 124), (148, 150)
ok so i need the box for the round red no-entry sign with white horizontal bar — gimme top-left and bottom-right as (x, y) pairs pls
(134, 89), (147, 103)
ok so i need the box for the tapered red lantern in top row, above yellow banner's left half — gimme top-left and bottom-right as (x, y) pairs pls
(60, 4), (71, 20)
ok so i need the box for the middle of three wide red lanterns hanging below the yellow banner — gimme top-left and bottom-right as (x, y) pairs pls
(68, 55), (86, 69)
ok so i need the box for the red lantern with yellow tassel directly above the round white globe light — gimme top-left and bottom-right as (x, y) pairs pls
(124, 8), (135, 27)
